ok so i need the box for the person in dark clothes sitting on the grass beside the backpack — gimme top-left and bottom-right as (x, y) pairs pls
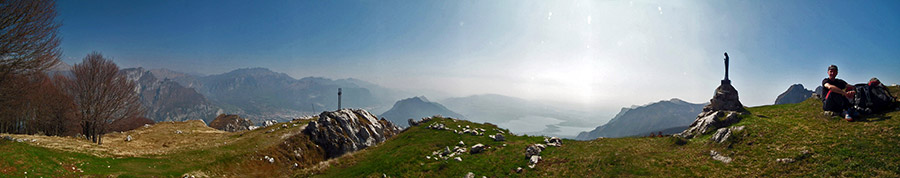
(822, 65), (856, 122)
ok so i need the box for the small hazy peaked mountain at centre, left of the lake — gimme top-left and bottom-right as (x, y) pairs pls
(379, 96), (465, 127)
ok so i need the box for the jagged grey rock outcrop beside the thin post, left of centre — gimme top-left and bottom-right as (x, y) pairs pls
(303, 109), (400, 158)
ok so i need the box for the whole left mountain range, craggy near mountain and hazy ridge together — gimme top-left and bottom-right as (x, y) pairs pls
(121, 68), (406, 123)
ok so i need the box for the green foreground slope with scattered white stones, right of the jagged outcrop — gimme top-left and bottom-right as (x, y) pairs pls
(312, 87), (900, 177)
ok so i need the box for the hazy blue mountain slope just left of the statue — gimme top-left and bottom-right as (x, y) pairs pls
(576, 98), (706, 140)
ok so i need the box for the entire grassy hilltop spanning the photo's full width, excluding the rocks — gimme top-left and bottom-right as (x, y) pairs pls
(0, 87), (900, 177)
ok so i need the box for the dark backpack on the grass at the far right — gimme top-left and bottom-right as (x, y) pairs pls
(851, 80), (895, 114)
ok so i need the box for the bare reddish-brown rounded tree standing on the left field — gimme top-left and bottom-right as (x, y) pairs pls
(65, 52), (144, 144)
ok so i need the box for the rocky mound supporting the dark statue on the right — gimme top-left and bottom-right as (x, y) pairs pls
(675, 81), (747, 139)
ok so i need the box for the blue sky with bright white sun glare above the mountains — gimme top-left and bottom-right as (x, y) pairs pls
(57, 0), (900, 112)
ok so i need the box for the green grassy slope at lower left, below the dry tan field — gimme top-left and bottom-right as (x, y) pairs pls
(0, 117), (324, 177)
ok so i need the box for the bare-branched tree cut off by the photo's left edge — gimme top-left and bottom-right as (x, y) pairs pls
(0, 0), (60, 132)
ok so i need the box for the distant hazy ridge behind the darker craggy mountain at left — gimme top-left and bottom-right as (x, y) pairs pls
(130, 67), (404, 123)
